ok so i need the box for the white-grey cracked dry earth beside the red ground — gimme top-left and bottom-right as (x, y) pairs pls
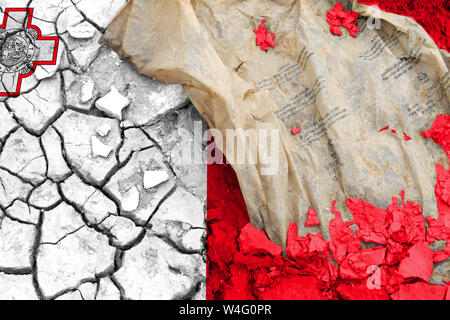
(0, 0), (206, 300)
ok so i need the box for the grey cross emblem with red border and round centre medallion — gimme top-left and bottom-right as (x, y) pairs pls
(0, 8), (59, 96)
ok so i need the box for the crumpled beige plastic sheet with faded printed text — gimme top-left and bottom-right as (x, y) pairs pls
(104, 0), (450, 246)
